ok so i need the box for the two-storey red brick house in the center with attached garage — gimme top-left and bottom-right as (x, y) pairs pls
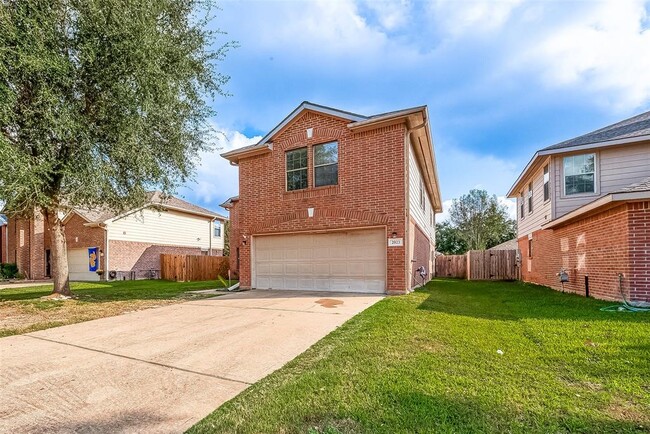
(222, 102), (442, 293)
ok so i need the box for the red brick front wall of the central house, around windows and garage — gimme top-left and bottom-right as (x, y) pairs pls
(223, 103), (440, 293)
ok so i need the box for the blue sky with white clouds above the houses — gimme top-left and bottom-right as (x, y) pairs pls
(179, 0), (650, 221)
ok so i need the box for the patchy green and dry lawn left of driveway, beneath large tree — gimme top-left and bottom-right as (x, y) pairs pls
(0, 280), (228, 337)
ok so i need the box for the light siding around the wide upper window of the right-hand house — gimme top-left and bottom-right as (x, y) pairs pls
(553, 143), (650, 218)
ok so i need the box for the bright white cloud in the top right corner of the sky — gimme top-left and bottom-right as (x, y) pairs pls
(523, 1), (650, 109)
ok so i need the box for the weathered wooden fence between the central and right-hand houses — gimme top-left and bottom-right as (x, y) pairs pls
(436, 250), (519, 280)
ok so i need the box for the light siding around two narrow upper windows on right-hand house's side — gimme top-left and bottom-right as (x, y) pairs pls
(517, 157), (553, 237)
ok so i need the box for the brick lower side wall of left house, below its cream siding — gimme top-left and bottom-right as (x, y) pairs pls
(108, 240), (202, 280)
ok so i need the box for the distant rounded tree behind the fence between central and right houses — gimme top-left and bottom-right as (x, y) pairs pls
(436, 190), (517, 255)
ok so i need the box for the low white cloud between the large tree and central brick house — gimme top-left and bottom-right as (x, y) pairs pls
(181, 127), (262, 210)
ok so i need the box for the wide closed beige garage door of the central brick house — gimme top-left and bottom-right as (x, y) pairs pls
(252, 229), (386, 293)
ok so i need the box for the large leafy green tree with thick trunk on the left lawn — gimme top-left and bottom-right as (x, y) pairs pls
(0, 0), (230, 295)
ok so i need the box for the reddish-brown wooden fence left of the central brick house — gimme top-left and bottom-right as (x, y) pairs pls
(160, 253), (229, 282)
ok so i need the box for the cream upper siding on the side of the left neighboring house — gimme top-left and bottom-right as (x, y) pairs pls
(107, 209), (213, 249)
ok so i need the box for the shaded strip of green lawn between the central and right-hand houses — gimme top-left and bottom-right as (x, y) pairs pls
(418, 279), (650, 324)
